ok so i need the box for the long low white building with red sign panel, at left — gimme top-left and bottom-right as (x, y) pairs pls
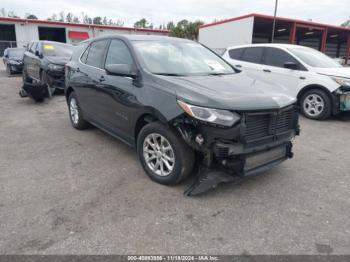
(0, 17), (169, 54)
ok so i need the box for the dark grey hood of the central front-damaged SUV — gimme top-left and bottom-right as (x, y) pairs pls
(155, 72), (296, 111)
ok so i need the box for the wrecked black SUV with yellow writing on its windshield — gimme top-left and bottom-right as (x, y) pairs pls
(23, 41), (73, 102)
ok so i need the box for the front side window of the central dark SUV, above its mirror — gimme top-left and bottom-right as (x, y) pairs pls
(106, 39), (133, 65)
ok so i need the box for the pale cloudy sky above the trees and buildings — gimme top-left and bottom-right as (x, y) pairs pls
(0, 0), (350, 26)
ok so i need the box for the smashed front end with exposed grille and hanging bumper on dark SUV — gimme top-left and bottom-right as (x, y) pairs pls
(177, 106), (300, 196)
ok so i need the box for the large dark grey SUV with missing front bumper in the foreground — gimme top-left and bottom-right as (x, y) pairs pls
(65, 35), (299, 195)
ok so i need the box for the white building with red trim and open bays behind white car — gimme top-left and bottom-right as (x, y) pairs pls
(199, 14), (350, 63)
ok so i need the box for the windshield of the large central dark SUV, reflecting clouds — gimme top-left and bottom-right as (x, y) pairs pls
(133, 41), (235, 76)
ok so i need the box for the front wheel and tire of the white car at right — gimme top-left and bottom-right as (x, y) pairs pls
(300, 89), (332, 120)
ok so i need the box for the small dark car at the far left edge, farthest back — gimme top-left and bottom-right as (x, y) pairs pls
(2, 48), (24, 76)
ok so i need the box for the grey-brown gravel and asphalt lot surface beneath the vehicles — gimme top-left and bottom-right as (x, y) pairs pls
(0, 63), (350, 254)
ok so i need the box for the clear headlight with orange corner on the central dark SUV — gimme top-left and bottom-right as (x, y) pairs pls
(177, 100), (241, 127)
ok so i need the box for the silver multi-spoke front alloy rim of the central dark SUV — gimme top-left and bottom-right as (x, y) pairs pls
(143, 133), (175, 177)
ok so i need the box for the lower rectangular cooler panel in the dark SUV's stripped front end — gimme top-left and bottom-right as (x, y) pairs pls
(244, 146), (287, 173)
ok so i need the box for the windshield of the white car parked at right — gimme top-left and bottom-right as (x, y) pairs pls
(288, 48), (342, 68)
